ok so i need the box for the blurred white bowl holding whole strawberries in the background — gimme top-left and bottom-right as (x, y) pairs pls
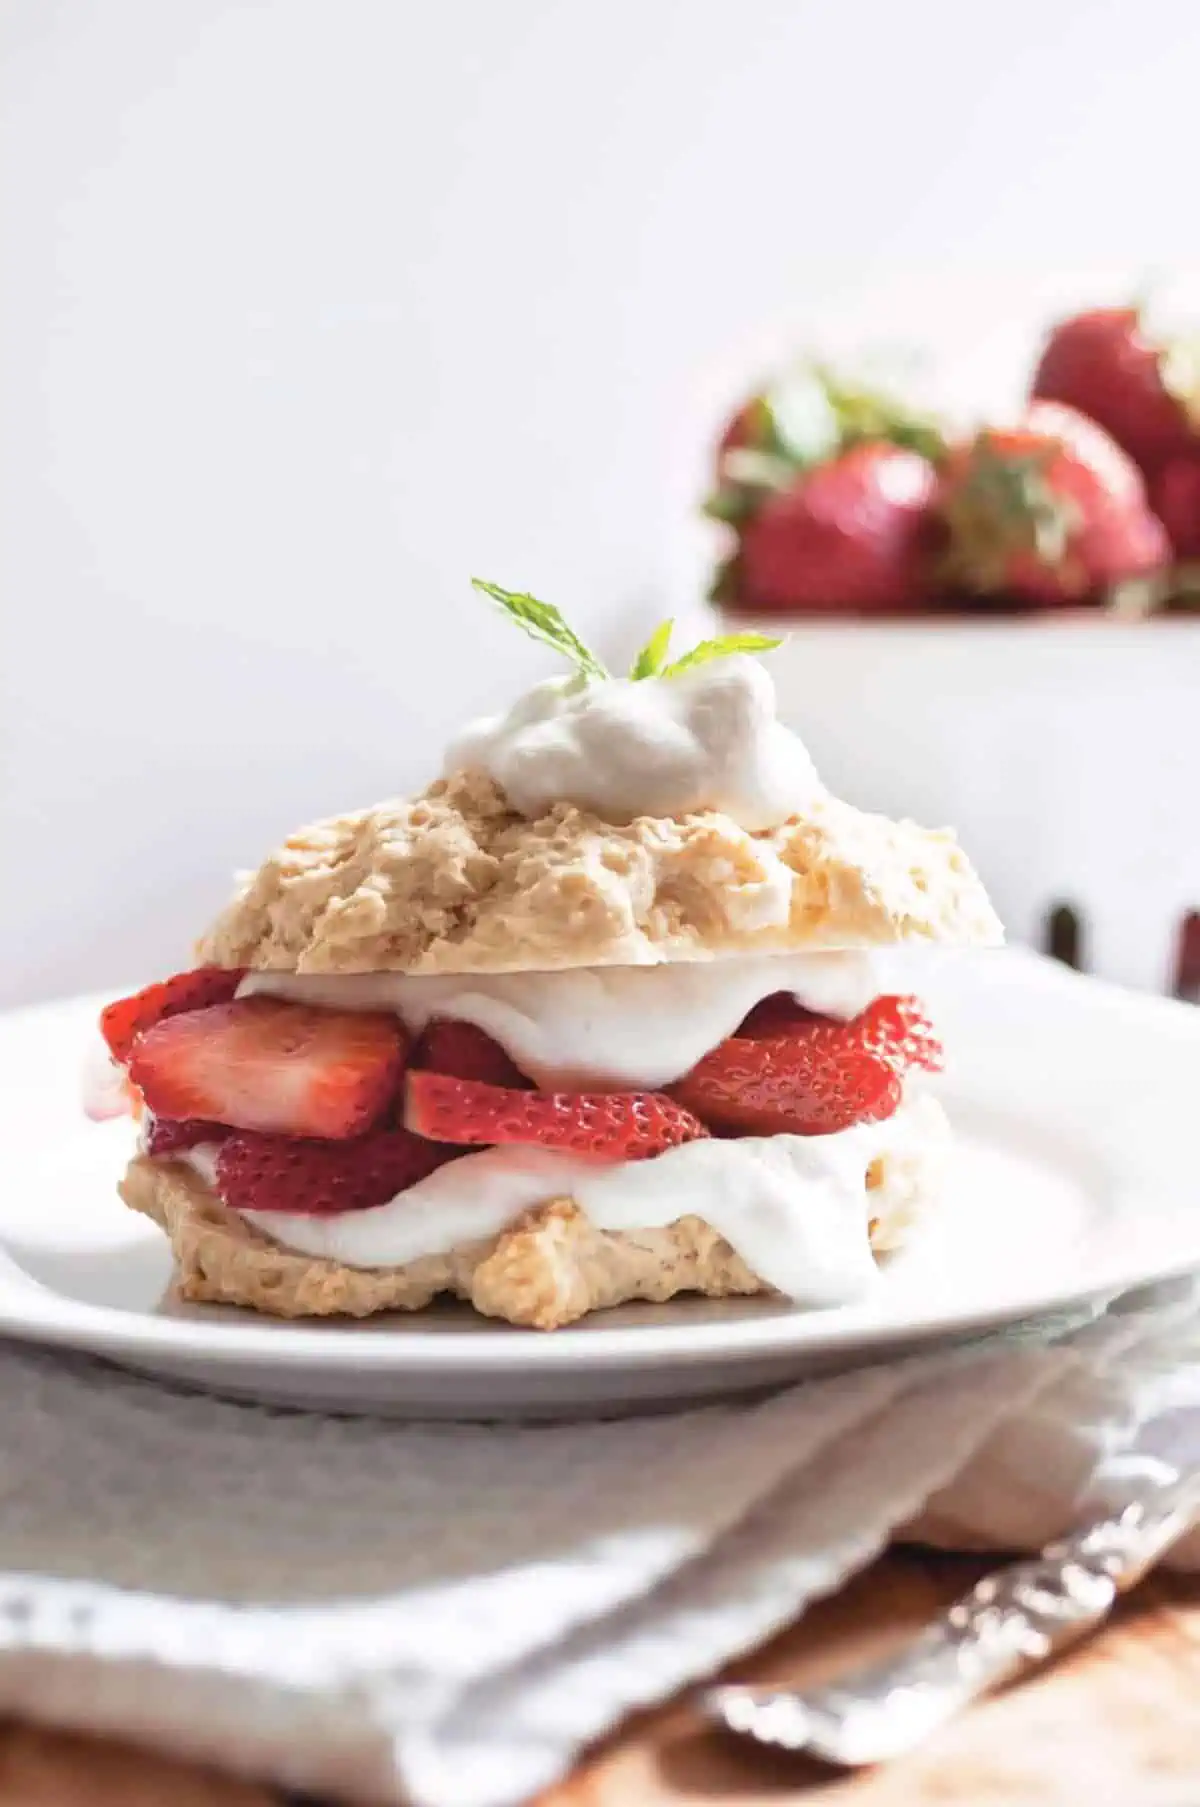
(762, 613), (1200, 990)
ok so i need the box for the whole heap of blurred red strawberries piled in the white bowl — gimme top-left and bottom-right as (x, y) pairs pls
(705, 334), (1200, 625)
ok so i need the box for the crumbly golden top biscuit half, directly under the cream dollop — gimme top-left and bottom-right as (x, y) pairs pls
(199, 772), (1001, 972)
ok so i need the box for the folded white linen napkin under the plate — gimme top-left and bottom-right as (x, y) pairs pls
(0, 1281), (1200, 1807)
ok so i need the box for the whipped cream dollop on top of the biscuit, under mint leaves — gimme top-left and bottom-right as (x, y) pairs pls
(445, 652), (824, 829)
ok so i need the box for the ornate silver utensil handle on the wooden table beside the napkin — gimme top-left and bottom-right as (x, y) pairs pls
(701, 1473), (1200, 1769)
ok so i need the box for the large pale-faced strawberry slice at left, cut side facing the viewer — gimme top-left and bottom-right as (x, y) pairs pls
(128, 997), (405, 1137)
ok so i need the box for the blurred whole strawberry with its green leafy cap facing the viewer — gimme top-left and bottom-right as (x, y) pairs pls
(938, 403), (1171, 607)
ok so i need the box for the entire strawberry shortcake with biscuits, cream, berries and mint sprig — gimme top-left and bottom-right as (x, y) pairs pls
(93, 584), (999, 1330)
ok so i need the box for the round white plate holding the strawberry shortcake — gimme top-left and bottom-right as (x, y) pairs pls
(0, 954), (1200, 1417)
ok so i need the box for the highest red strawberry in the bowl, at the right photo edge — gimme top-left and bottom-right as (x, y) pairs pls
(1032, 307), (1200, 472)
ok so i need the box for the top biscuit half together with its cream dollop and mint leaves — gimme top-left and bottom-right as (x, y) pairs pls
(199, 585), (1001, 974)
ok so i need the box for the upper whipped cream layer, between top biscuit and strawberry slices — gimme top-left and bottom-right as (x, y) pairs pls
(239, 950), (882, 1091)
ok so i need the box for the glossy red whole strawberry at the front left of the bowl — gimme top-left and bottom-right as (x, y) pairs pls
(734, 441), (938, 614)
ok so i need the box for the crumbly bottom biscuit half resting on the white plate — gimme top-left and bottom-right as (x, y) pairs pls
(121, 1099), (947, 1330)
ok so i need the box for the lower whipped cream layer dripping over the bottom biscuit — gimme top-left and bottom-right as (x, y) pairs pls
(192, 1099), (923, 1305)
